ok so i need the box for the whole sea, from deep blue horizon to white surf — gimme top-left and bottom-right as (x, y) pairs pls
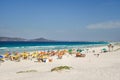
(0, 41), (109, 54)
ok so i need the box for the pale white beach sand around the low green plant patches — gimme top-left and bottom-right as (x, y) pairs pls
(0, 47), (120, 80)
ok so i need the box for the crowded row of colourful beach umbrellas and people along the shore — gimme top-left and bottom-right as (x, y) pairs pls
(0, 44), (114, 62)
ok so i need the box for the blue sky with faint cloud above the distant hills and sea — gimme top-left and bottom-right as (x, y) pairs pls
(0, 0), (120, 41)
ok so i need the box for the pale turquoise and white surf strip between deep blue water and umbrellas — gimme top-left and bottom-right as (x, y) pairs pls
(0, 44), (106, 54)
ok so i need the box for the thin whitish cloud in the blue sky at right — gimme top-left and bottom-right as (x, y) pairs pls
(87, 21), (120, 29)
